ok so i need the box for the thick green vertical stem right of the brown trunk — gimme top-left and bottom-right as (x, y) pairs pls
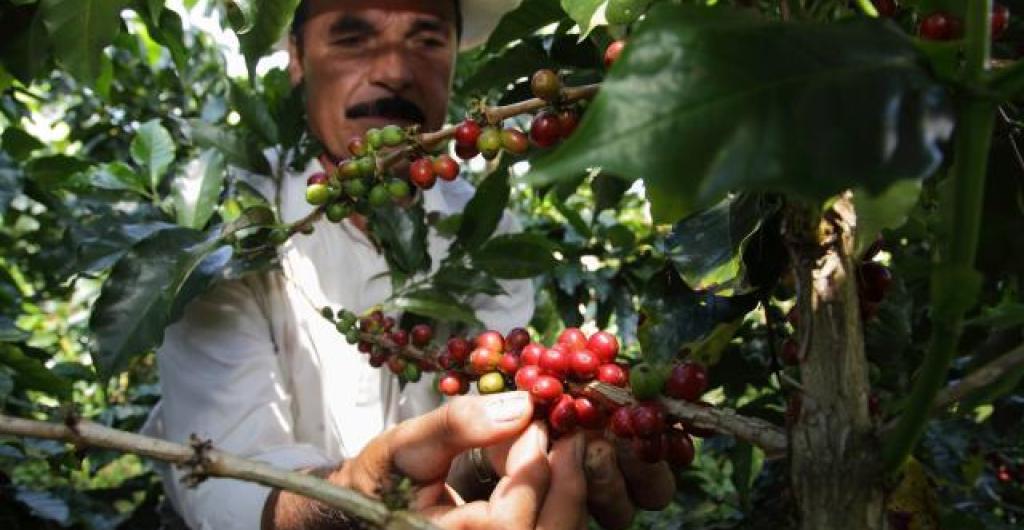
(882, 0), (995, 472)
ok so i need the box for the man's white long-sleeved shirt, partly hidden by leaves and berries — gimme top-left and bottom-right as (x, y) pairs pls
(143, 151), (534, 530)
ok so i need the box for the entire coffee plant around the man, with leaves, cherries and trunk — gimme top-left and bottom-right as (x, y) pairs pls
(0, 0), (1024, 530)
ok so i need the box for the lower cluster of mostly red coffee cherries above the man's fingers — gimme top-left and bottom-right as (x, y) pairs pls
(323, 308), (714, 467)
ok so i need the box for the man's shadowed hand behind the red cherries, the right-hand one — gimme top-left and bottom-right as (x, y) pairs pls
(584, 437), (676, 530)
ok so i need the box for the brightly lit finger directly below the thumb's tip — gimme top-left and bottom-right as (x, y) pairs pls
(489, 422), (551, 528)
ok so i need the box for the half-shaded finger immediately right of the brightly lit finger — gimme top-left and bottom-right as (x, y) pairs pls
(537, 433), (587, 530)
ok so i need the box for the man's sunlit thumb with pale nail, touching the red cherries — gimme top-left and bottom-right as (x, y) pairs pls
(388, 392), (534, 482)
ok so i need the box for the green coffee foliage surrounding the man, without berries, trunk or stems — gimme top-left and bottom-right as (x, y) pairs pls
(0, 0), (1024, 529)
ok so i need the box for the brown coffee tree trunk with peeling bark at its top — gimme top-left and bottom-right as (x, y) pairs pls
(786, 193), (885, 530)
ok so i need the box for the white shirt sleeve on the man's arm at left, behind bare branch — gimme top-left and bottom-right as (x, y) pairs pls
(157, 281), (330, 530)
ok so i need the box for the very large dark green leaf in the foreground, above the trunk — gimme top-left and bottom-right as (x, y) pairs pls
(527, 4), (951, 226)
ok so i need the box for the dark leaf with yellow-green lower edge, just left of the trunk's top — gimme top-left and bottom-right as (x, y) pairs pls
(665, 194), (777, 296)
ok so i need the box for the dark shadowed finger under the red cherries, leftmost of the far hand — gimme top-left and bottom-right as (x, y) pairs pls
(584, 440), (636, 530)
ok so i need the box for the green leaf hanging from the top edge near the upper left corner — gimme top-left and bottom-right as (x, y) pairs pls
(40, 0), (128, 84)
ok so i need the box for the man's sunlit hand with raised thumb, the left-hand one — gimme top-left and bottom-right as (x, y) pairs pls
(263, 392), (586, 530)
